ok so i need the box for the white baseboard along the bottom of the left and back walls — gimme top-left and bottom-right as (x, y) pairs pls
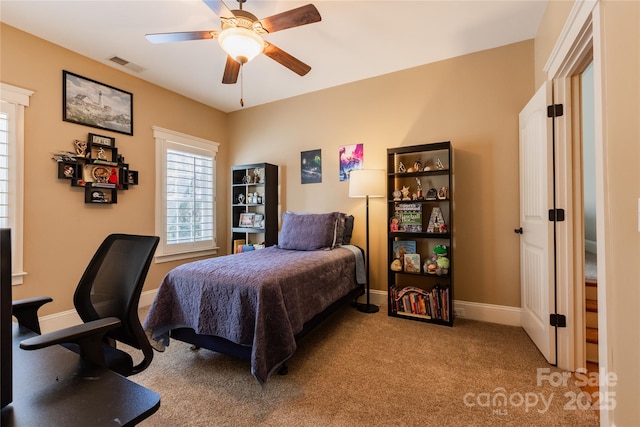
(40, 289), (522, 333)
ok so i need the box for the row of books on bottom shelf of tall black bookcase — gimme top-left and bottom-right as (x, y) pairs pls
(389, 286), (450, 322)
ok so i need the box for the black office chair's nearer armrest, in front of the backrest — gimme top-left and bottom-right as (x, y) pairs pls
(20, 317), (122, 367)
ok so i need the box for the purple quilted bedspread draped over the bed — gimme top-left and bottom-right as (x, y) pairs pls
(144, 247), (362, 383)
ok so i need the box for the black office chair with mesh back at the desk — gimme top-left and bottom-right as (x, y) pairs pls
(13, 234), (160, 376)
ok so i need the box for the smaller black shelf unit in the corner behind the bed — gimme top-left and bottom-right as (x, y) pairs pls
(231, 163), (278, 251)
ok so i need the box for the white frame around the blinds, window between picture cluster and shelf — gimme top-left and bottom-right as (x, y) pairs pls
(152, 126), (220, 263)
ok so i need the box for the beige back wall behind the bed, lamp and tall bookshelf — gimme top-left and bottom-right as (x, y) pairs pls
(230, 41), (534, 307)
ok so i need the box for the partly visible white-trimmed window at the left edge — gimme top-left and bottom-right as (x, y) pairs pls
(0, 83), (33, 285)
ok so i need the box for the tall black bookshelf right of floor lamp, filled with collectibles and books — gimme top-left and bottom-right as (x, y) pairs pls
(387, 141), (454, 326)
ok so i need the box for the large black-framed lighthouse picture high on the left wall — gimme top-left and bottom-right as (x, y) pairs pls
(62, 70), (133, 135)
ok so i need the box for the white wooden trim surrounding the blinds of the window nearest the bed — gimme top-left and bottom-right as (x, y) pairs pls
(152, 126), (220, 263)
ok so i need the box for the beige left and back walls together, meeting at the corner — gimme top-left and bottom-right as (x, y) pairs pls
(1, 20), (534, 314)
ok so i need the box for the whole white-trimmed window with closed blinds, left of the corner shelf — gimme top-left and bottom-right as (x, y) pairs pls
(153, 126), (219, 262)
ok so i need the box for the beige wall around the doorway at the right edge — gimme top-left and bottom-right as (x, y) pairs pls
(535, 1), (640, 426)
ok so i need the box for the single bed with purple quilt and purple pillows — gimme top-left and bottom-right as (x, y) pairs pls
(143, 212), (366, 384)
